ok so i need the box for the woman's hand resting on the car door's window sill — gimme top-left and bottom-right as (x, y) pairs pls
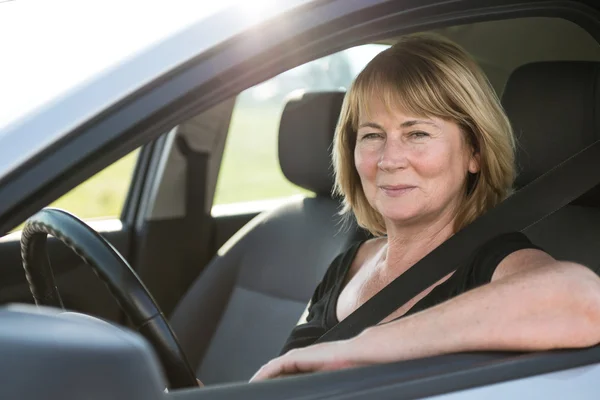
(250, 340), (368, 382)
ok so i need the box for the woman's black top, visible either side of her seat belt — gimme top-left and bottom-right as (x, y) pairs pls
(281, 232), (539, 354)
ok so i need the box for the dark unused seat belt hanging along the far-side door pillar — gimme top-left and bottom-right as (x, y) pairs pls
(175, 135), (214, 293)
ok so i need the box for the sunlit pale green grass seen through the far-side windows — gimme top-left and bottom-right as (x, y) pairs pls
(52, 108), (307, 219)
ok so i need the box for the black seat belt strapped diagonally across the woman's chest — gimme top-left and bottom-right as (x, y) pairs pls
(316, 141), (600, 343)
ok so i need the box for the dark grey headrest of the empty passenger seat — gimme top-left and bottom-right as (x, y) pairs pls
(279, 92), (345, 196)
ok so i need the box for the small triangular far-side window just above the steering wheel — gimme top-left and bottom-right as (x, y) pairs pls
(50, 150), (139, 220)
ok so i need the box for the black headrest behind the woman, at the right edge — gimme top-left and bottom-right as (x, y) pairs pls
(502, 61), (600, 188)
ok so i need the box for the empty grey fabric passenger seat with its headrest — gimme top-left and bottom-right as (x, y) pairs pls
(171, 92), (364, 384)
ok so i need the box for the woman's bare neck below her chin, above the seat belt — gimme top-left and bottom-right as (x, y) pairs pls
(385, 208), (454, 274)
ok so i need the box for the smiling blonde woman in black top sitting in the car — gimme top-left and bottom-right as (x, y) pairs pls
(248, 35), (600, 381)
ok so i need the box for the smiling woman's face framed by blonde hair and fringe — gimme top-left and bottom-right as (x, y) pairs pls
(354, 102), (479, 226)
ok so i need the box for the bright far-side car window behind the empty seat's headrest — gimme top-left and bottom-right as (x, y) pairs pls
(213, 44), (388, 209)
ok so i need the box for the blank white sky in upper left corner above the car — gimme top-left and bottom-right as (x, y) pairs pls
(0, 0), (238, 131)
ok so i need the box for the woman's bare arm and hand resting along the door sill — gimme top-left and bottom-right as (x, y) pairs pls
(253, 249), (600, 380)
